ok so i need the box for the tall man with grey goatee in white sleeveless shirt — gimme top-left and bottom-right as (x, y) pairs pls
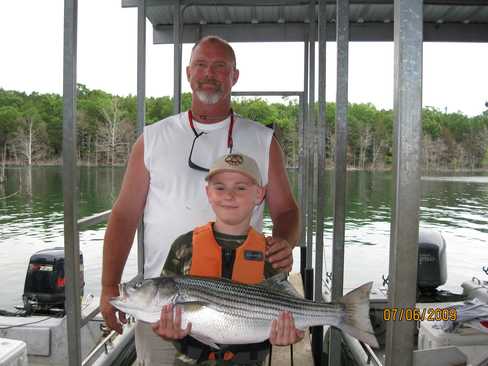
(100, 36), (299, 365)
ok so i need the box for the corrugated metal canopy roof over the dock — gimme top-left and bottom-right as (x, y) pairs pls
(122, 0), (488, 43)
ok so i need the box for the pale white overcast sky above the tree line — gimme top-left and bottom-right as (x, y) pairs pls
(0, 0), (488, 116)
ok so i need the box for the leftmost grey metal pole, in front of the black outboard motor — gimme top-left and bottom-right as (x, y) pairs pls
(63, 0), (81, 366)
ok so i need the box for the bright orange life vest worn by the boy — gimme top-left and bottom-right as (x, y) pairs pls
(190, 222), (266, 284)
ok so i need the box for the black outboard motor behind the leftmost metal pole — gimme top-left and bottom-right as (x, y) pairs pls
(22, 247), (85, 312)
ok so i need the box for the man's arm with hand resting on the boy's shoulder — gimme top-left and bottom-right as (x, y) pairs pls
(266, 136), (300, 271)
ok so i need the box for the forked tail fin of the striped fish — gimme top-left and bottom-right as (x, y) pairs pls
(338, 282), (379, 348)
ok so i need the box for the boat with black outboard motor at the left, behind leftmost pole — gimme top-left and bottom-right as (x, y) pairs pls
(0, 247), (135, 366)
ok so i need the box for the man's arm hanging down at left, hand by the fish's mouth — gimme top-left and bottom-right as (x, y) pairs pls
(100, 136), (149, 333)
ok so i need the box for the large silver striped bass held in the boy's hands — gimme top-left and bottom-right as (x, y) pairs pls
(111, 275), (378, 349)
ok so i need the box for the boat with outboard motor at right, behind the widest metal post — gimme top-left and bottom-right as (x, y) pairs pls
(324, 229), (488, 366)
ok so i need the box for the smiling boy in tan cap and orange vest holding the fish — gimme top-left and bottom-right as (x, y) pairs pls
(153, 154), (303, 365)
